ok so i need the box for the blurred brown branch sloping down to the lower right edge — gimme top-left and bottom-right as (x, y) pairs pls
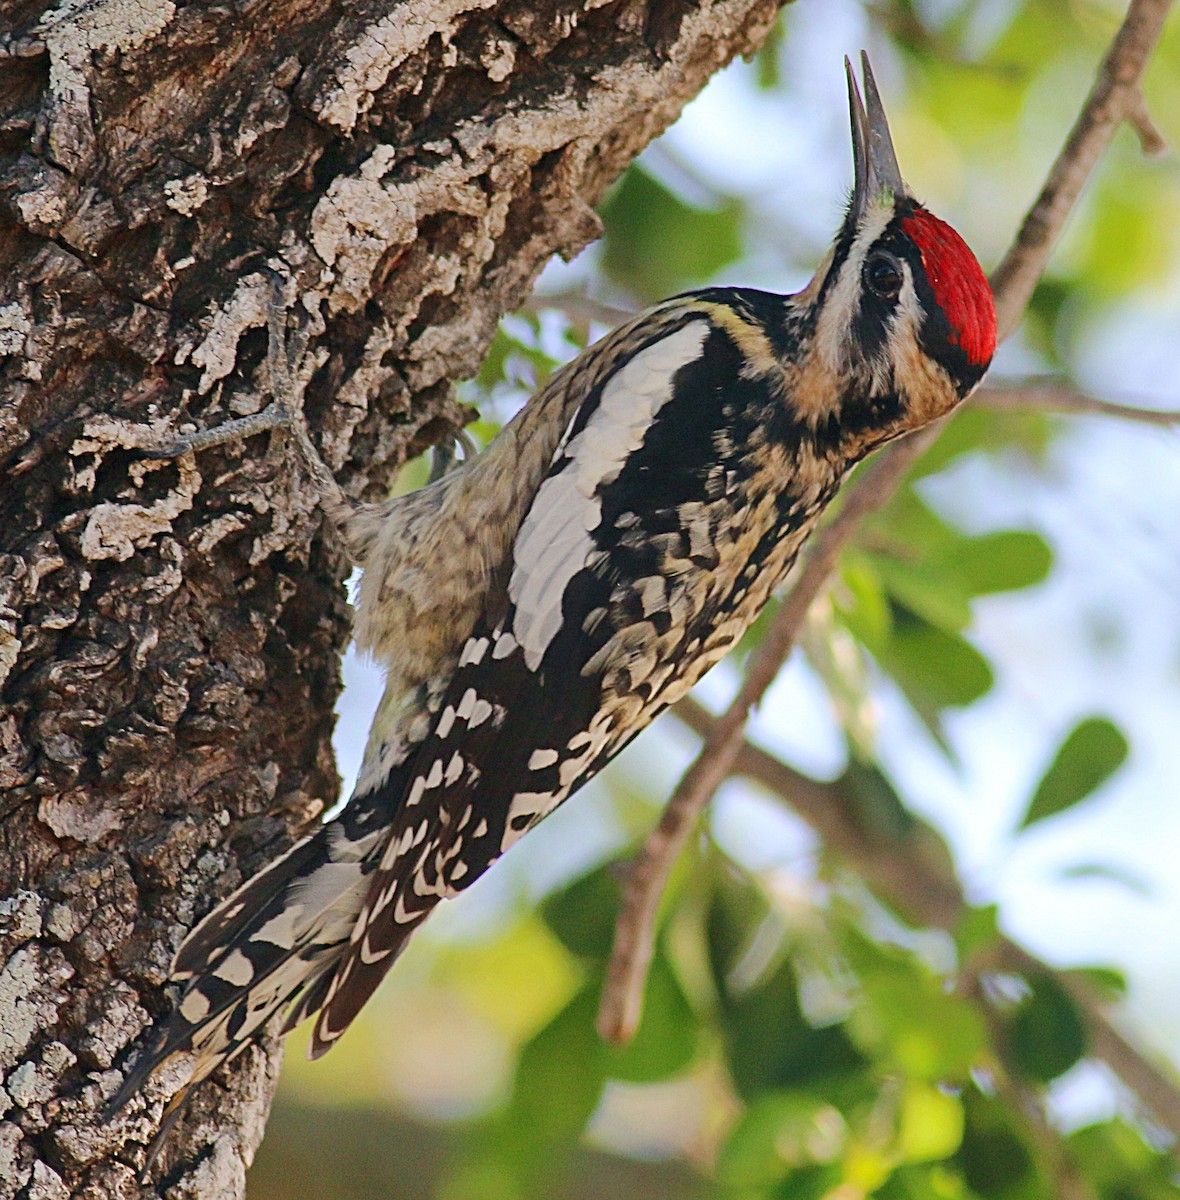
(672, 698), (1180, 1142)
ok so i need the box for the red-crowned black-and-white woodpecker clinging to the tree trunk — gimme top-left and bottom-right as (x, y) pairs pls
(112, 58), (995, 1137)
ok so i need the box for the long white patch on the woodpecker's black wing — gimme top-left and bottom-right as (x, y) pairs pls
(508, 320), (709, 671)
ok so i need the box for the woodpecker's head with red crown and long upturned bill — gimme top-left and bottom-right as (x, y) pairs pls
(791, 56), (995, 457)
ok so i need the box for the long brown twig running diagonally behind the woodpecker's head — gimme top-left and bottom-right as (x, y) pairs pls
(598, 0), (1169, 1042)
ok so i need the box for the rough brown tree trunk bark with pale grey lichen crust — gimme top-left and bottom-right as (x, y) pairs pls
(0, 0), (777, 1200)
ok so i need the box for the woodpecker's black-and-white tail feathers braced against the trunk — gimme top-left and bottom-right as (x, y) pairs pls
(107, 800), (383, 1116)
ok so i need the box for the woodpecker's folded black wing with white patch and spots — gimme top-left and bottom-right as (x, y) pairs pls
(312, 302), (792, 1054)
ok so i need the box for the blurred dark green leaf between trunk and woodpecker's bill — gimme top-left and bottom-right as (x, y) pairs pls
(603, 163), (742, 302)
